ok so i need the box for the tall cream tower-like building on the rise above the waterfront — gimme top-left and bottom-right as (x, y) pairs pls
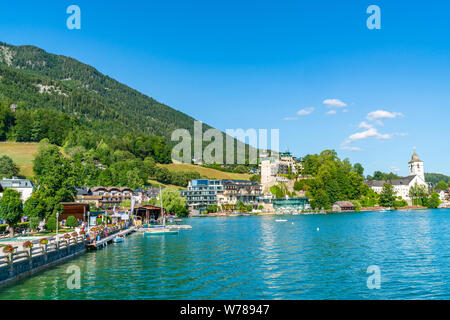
(260, 152), (302, 193)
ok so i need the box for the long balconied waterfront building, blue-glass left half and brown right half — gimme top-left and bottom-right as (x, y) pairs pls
(181, 179), (262, 211)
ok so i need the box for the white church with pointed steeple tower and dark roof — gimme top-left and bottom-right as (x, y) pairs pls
(366, 151), (429, 205)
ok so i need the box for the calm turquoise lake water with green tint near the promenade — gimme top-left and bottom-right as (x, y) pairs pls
(0, 209), (450, 299)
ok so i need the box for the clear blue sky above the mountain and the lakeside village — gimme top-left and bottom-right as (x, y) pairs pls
(0, 0), (450, 175)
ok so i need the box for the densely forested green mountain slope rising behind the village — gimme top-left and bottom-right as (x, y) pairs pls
(0, 43), (209, 141)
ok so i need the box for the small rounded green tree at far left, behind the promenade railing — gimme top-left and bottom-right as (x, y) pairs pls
(0, 189), (23, 237)
